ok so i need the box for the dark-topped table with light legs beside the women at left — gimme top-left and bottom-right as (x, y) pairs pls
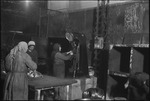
(29, 75), (77, 100)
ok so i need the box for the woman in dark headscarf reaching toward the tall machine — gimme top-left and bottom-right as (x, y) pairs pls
(51, 43), (73, 78)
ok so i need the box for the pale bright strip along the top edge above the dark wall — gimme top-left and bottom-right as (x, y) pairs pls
(48, 0), (132, 12)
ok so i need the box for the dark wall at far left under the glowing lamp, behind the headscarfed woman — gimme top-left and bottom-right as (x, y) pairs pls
(1, 0), (46, 59)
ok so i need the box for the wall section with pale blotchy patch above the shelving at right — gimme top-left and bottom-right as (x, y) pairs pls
(107, 2), (149, 44)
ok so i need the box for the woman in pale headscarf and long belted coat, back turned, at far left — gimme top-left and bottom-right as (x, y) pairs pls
(4, 42), (37, 100)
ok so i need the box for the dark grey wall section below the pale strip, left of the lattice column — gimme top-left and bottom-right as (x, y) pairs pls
(44, 9), (93, 40)
